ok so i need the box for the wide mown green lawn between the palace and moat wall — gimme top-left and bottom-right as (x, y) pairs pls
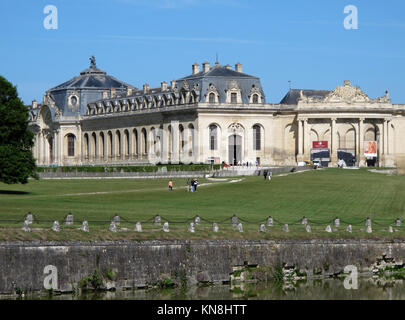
(0, 169), (405, 240)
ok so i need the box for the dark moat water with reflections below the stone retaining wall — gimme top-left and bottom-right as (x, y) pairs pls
(4, 278), (405, 300)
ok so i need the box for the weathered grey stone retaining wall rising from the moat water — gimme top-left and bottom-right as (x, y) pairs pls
(0, 240), (405, 294)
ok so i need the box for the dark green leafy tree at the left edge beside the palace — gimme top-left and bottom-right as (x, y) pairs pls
(0, 76), (38, 184)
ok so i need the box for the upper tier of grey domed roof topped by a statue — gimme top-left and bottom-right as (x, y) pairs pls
(49, 57), (132, 91)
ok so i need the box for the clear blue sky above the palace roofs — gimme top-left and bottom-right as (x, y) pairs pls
(0, 0), (405, 104)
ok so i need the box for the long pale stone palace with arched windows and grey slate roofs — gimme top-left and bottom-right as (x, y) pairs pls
(29, 57), (405, 167)
